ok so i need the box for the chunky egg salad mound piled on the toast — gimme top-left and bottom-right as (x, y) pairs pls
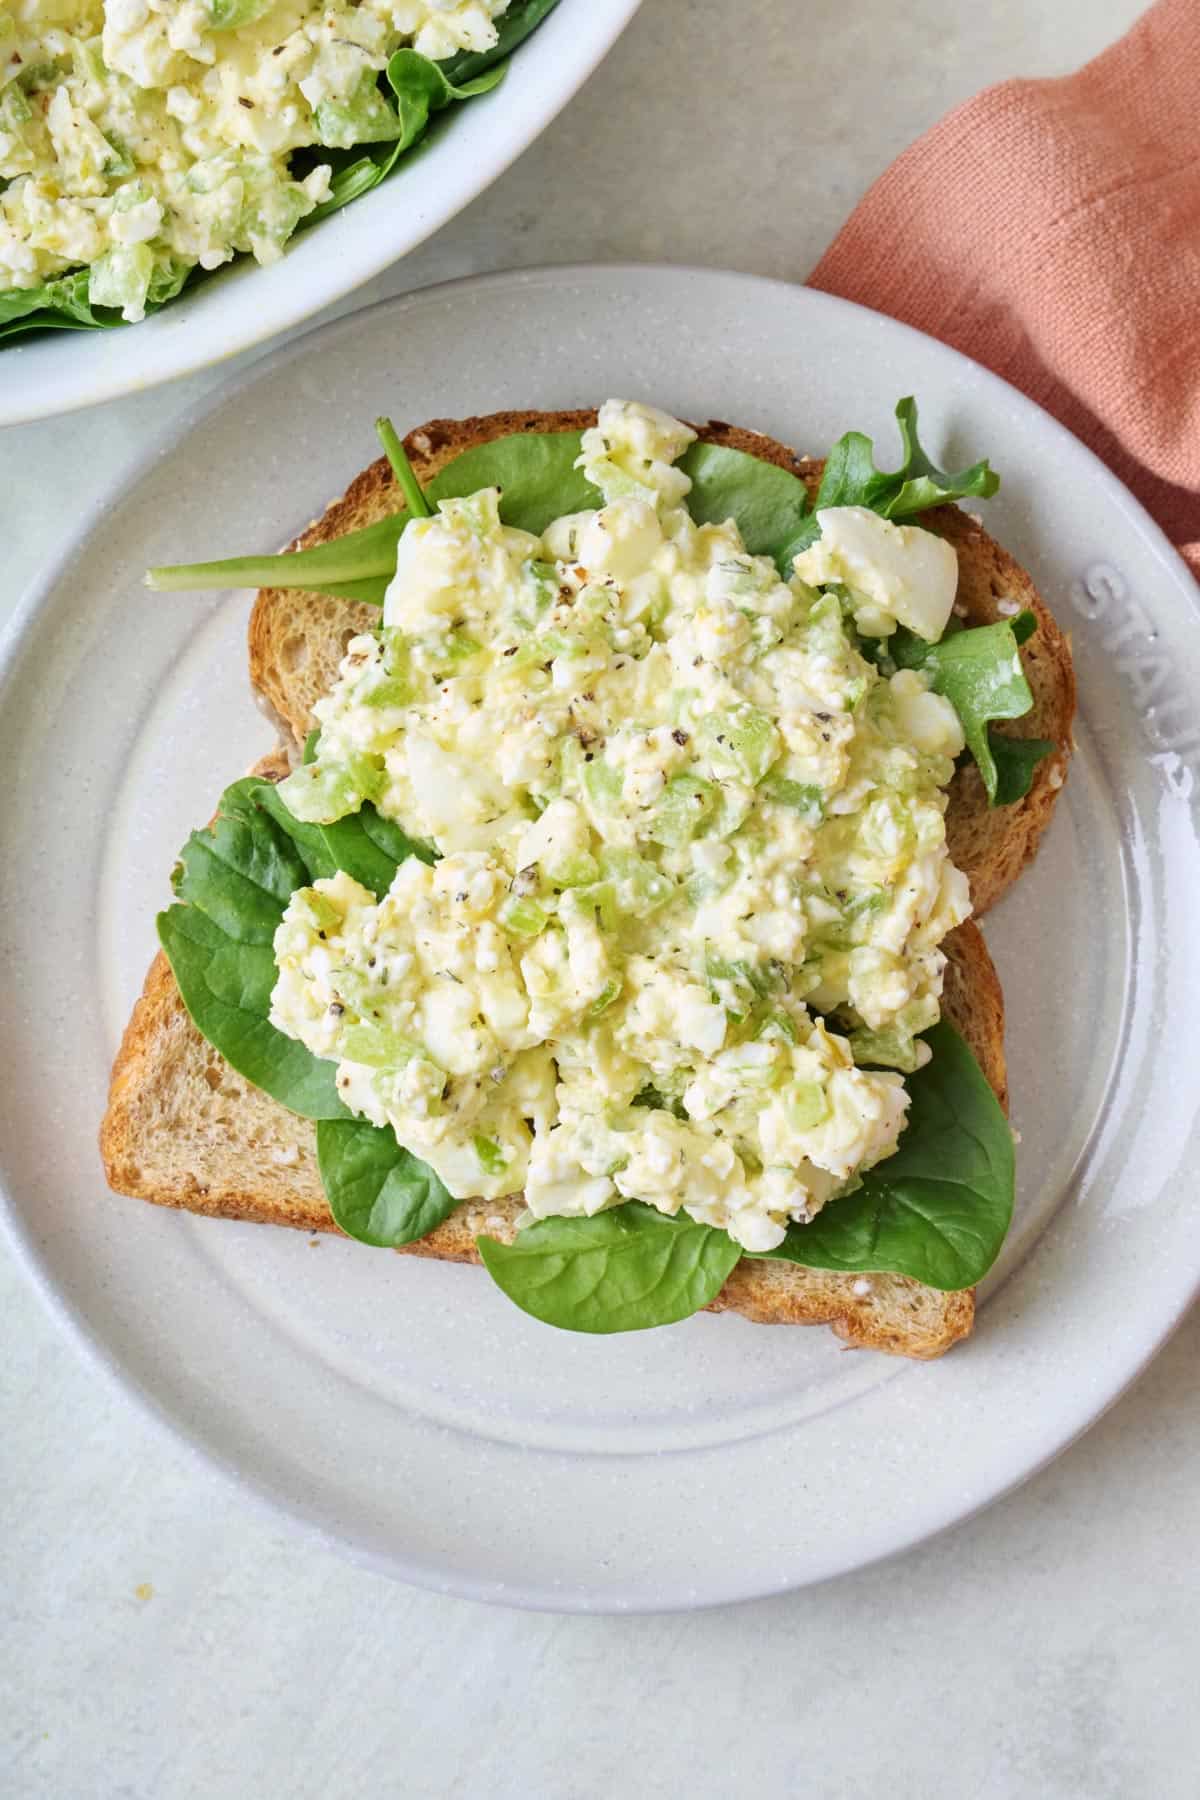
(272, 401), (970, 1251)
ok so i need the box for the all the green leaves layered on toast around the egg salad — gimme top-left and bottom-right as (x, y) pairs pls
(148, 400), (1049, 1332)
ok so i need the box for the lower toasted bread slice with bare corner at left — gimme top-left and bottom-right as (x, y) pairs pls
(101, 754), (1007, 1357)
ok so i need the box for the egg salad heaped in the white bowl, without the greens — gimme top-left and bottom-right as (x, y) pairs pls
(0, 0), (509, 320)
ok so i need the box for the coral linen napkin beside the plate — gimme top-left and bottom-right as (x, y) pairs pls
(810, 0), (1200, 574)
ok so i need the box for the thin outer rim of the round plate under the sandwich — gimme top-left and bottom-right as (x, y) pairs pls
(0, 263), (1200, 1613)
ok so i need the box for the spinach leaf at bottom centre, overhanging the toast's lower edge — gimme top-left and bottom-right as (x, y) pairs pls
(475, 1201), (741, 1332)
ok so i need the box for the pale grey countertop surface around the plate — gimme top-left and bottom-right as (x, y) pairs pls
(0, 0), (1200, 1800)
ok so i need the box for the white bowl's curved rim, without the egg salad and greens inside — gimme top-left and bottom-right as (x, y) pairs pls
(0, 0), (640, 425)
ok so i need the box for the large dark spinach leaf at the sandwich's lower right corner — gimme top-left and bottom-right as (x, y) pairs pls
(765, 1021), (1015, 1292)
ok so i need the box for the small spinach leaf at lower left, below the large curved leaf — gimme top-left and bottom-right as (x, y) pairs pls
(317, 1120), (459, 1249)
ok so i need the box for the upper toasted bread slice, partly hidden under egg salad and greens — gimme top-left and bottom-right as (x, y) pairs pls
(250, 410), (1076, 916)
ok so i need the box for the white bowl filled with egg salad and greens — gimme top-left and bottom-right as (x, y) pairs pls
(0, 0), (639, 425)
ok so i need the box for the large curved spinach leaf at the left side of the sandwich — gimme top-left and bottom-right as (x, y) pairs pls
(158, 776), (430, 1120)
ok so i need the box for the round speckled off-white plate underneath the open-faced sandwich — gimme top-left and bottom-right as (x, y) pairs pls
(0, 268), (1200, 1609)
